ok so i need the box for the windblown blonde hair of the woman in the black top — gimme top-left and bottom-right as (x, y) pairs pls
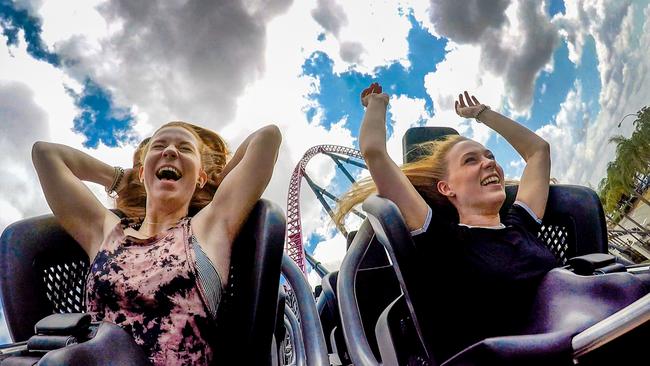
(334, 135), (469, 227)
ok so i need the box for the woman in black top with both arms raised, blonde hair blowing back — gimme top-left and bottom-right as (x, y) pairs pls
(336, 83), (556, 360)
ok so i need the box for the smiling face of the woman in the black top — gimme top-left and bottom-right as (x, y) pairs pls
(438, 140), (506, 217)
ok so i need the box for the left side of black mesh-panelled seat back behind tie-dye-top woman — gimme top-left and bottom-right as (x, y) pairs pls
(0, 215), (88, 342)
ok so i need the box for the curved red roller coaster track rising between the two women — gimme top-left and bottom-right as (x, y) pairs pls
(285, 145), (363, 272)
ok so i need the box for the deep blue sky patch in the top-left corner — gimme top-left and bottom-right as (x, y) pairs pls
(0, 0), (61, 67)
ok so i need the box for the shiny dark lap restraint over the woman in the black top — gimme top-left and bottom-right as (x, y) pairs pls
(443, 268), (648, 366)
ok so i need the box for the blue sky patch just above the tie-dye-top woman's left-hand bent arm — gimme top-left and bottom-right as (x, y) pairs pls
(68, 79), (137, 148)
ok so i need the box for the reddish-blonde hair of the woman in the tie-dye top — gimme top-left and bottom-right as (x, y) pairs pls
(116, 121), (229, 217)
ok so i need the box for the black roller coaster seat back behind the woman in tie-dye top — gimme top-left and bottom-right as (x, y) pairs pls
(0, 199), (285, 365)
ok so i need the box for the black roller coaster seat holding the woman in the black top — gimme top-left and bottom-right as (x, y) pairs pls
(338, 127), (650, 365)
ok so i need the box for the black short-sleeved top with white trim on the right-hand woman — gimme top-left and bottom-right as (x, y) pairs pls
(413, 202), (557, 362)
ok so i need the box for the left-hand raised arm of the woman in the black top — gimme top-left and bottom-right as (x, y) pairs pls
(359, 83), (428, 230)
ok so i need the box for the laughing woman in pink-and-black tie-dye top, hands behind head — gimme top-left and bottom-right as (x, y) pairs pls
(32, 122), (281, 365)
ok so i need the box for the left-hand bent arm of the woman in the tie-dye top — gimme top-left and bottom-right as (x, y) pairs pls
(32, 141), (119, 259)
